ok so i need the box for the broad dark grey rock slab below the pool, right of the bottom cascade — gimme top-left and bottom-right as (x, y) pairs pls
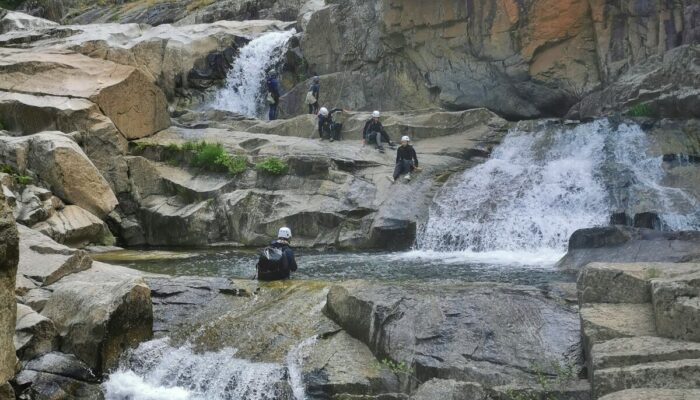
(325, 281), (582, 386)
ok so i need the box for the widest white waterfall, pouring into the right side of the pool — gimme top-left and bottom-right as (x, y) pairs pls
(417, 120), (700, 260)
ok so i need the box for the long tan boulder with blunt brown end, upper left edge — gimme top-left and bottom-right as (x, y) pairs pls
(0, 48), (170, 139)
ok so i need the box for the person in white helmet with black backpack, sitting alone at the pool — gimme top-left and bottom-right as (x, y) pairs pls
(255, 227), (297, 281)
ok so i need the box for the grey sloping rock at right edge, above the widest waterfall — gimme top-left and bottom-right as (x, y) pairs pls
(569, 44), (700, 118)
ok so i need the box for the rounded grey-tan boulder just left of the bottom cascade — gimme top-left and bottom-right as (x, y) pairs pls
(41, 263), (153, 374)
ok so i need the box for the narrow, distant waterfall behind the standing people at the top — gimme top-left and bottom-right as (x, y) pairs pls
(212, 30), (296, 117)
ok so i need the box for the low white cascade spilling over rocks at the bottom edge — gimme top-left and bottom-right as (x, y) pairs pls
(103, 338), (300, 400)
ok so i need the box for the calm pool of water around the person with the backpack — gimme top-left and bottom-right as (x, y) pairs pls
(95, 249), (575, 285)
